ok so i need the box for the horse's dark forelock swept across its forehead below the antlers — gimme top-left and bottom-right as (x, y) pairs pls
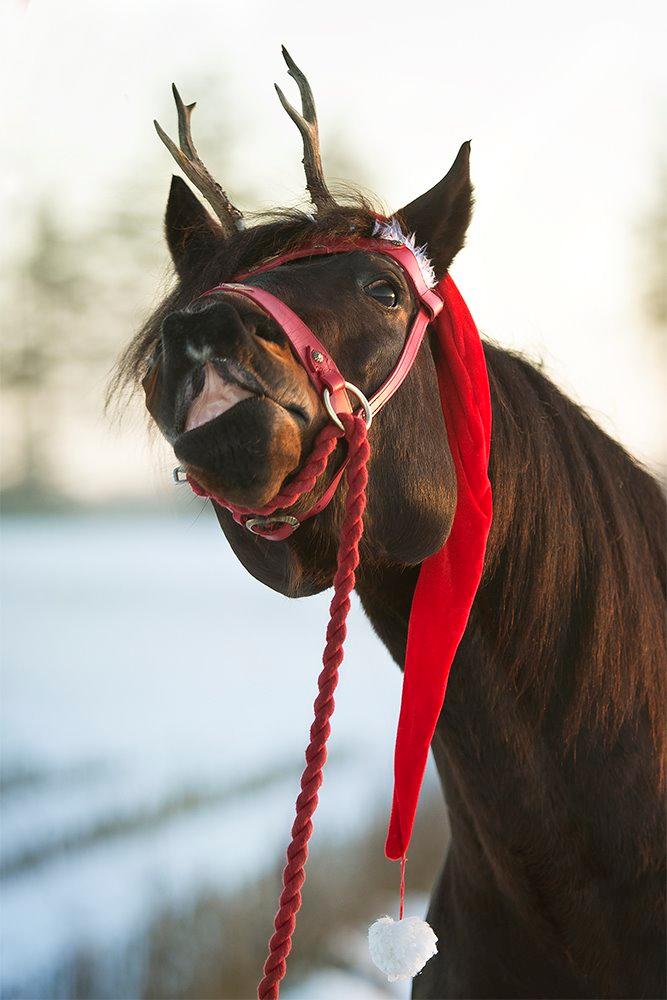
(107, 199), (378, 404)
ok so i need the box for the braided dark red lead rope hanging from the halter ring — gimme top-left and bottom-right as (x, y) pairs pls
(257, 414), (370, 1000)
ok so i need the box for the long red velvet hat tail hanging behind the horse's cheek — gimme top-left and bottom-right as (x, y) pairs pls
(385, 276), (492, 860)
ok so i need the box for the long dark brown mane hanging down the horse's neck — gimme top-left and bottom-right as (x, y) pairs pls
(478, 346), (666, 764)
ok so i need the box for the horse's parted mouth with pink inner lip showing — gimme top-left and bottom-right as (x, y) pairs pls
(179, 358), (308, 433)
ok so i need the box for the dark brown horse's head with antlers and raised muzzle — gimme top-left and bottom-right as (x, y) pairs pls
(123, 53), (472, 594)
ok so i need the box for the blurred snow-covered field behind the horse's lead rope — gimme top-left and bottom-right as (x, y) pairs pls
(0, 512), (422, 1000)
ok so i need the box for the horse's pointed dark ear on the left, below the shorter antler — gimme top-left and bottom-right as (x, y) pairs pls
(164, 175), (223, 278)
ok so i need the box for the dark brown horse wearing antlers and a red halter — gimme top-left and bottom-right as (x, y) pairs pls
(110, 53), (666, 998)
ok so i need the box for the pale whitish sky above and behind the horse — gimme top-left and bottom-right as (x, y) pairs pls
(0, 0), (667, 495)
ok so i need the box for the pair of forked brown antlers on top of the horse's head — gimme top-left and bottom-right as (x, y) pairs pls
(153, 45), (336, 225)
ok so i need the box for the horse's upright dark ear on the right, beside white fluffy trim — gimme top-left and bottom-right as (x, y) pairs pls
(397, 142), (473, 280)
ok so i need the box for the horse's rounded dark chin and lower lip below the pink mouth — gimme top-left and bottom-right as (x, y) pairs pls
(174, 389), (302, 510)
